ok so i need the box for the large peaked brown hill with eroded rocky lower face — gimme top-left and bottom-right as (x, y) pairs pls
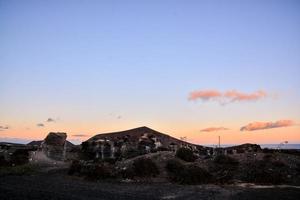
(81, 126), (208, 159)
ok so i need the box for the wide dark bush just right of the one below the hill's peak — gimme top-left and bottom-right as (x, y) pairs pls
(166, 159), (211, 184)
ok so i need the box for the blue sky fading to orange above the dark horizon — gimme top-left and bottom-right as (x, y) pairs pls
(0, 0), (300, 144)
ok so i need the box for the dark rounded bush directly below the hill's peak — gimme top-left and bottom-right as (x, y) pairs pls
(132, 158), (159, 177)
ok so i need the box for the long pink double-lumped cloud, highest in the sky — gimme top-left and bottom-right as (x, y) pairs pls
(188, 90), (268, 104)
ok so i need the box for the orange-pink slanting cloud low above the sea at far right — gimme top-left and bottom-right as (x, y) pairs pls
(240, 120), (296, 131)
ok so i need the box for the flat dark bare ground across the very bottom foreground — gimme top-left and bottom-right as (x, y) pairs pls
(0, 168), (300, 200)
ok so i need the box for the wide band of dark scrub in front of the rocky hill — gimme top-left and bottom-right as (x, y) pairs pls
(69, 149), (300, 185)
